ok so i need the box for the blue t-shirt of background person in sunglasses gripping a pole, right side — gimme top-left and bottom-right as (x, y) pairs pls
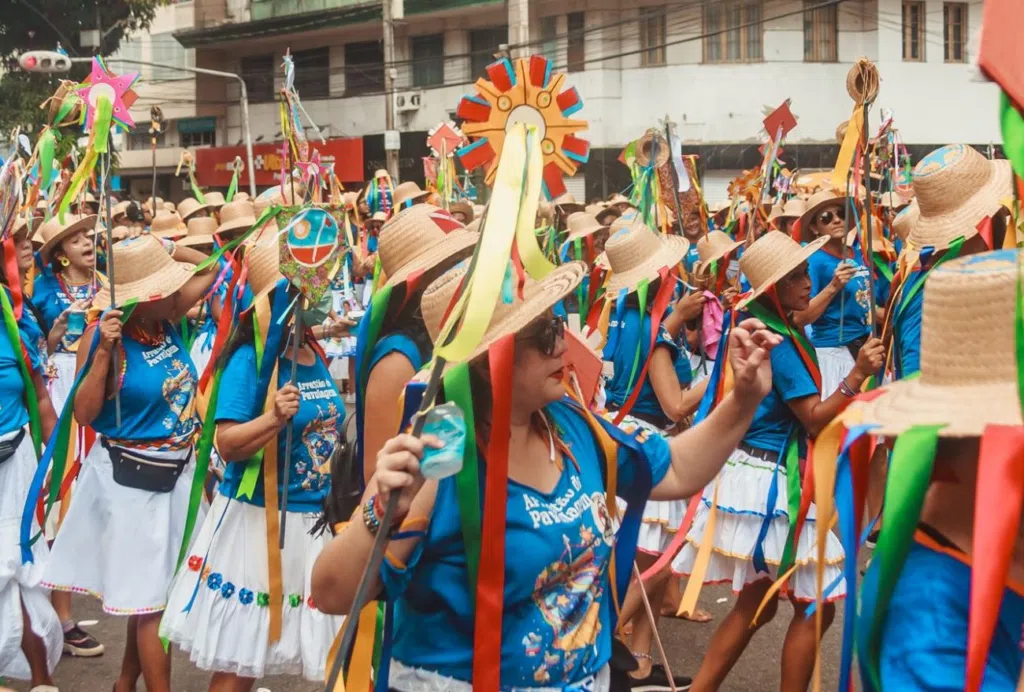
(807, 250), (871, 348)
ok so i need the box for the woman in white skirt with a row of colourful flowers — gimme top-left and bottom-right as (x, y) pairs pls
(161, 239), (345, 690)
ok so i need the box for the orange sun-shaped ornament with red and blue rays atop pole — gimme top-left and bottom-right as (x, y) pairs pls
(457, 55), (590, 199)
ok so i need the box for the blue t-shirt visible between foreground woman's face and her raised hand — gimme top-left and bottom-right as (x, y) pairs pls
(602, 307), (693, 416)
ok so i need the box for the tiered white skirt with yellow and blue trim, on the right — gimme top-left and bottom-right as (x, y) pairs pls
(672, 449), (846, 601)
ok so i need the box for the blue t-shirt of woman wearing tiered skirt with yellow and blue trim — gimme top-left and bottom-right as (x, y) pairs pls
(743, 336), (818, 452)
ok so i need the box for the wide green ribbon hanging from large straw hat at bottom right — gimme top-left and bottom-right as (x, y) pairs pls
(861, 425), (944, 690)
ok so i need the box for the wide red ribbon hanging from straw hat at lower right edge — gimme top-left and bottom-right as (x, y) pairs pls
(964, 425), (1024, 692)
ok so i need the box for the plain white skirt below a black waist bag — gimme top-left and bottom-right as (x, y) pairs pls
(43, 438), (204, 615)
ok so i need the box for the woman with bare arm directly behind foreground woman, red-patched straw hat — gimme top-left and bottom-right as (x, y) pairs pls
(355, 204), (479, 487)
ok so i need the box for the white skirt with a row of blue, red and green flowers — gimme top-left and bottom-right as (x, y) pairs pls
(160, 494), (345, 682)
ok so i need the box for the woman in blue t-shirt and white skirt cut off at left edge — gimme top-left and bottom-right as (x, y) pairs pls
(0, 214), (65, 687)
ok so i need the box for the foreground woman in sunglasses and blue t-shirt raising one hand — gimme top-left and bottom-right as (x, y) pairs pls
(311, 262), (778, 692)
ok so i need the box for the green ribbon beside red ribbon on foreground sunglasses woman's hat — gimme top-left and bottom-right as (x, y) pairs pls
(444, 362), (481, 594)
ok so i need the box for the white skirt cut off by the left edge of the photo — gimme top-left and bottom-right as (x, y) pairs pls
(0, 433), (63, 680)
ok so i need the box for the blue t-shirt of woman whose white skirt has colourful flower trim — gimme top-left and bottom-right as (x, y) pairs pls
(216, 344), (345, 512)
